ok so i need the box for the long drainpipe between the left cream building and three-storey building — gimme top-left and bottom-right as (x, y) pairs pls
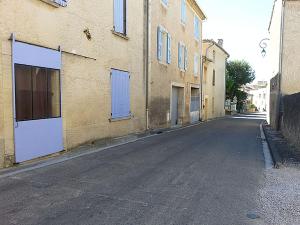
(144, 0), (151, 130)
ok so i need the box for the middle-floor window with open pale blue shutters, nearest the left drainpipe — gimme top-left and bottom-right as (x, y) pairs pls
(157, 26), (171, 64)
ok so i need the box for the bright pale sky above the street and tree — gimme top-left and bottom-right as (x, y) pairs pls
(197, 0), (274, 80)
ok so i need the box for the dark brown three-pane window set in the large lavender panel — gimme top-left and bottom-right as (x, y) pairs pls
(15, 64), (61, 121)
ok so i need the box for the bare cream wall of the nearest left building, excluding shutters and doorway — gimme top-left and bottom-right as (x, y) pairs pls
(0, 0), (146, 167)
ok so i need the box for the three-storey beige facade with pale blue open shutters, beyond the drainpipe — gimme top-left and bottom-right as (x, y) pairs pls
(149, 0), (206, 129)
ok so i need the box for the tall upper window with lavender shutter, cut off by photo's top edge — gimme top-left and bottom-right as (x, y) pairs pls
(114, 0), (127, 35)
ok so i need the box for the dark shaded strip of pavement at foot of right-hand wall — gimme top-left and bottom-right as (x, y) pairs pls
(263, 123), (300, 168)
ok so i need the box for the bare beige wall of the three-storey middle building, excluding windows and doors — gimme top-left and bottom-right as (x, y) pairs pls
(149, 0), (205, 129)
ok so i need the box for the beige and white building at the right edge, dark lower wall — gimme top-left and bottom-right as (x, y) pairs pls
(268, 0), (300, 150)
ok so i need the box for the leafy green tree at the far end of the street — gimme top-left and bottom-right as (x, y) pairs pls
(226, 60), (255, 111)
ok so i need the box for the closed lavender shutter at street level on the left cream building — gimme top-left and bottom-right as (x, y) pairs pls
(111, 70), (130, 119)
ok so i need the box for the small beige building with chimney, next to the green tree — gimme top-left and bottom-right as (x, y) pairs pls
(202, 40), (229, 120)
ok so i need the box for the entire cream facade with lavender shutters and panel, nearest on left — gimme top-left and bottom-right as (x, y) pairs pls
(0, 0), (146, 167)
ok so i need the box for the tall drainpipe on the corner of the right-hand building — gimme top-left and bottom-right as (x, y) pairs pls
(276, 0), (286, 130)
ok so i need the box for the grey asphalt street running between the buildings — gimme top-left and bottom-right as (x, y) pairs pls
(0, 115), (265, 225)
